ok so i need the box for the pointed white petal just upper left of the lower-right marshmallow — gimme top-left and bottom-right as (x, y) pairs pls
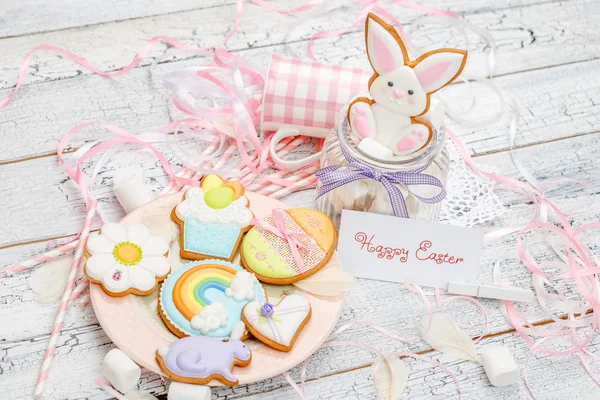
(420, 313), (479, 362)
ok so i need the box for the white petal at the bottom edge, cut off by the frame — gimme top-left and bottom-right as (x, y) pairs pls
(373, 356), (408, 400)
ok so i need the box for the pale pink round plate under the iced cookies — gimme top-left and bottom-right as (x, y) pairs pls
(90, 193), (344, 386)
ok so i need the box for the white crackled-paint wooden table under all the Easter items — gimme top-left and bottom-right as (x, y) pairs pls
(0, 0), (600, 400)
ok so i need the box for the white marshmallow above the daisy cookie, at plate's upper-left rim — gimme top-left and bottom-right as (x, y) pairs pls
(113, 168), (152, 213)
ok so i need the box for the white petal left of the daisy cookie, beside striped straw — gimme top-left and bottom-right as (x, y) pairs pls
(29, 255), (83, 303)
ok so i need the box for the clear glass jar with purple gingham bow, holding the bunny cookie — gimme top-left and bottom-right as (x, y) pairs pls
(317, 111), (450, 229)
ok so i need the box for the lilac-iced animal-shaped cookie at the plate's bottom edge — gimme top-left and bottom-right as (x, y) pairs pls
(156, 320), (252, 386)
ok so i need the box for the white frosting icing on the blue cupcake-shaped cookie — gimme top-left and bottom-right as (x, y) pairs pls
(175, 187), (253, 228)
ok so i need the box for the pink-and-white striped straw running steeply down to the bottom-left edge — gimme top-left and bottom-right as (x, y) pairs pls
(33, 200), (98, 398)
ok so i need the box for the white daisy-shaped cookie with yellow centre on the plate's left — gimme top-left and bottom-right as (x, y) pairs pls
(84, 223), (171, 296)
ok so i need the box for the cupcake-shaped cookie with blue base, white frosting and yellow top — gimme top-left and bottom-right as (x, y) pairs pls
(171, 174), (254, 261)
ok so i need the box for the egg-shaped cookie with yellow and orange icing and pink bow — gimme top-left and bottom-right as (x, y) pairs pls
(241, 208), (337, 285)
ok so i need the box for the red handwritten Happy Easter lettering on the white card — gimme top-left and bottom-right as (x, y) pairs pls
(354, 232), (464, 264)
